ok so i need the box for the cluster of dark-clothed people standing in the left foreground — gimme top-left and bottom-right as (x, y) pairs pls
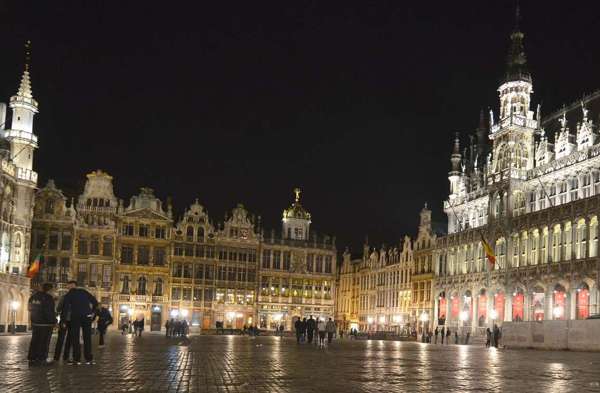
(27, 281), (113, 366)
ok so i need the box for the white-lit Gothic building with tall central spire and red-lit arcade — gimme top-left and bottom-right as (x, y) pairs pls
(434, 16), (600, 330)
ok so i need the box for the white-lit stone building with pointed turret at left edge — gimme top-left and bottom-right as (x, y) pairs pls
(0, 52), (38, 332)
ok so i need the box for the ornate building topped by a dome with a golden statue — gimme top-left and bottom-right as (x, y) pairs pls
(258, 189), (337, 330)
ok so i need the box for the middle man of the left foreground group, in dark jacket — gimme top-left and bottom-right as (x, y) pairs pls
(63, 281), (98, 364)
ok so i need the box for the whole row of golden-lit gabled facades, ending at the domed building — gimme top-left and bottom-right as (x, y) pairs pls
(33, 178), (336, 330)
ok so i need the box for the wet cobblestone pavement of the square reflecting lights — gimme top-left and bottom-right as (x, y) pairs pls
(0, 333), (600, 393)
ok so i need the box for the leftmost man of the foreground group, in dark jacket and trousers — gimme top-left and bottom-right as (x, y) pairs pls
(27, 283), (56, 366)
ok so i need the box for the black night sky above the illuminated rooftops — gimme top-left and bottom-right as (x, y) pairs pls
(0, 0), (600, 251)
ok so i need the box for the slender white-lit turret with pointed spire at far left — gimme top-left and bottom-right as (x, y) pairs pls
(4, 41), (38, 272)
